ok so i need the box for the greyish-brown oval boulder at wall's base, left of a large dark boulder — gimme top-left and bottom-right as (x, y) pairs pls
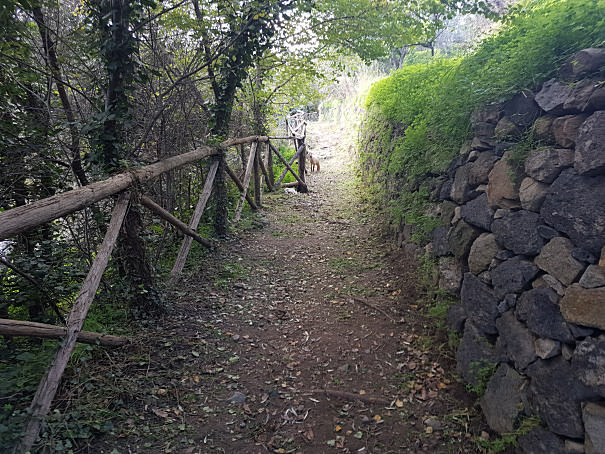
(479, 364), (528, 433)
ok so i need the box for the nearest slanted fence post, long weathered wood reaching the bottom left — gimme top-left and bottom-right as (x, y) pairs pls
(18, 193), (130, 454)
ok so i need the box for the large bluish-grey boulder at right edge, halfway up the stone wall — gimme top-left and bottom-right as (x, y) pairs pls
(540, 169), (605, 256)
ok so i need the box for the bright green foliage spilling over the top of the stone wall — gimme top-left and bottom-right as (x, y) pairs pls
(360, 0), (605, 243)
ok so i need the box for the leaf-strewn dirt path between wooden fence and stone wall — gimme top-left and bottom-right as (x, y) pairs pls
(89, 124), (478, 454)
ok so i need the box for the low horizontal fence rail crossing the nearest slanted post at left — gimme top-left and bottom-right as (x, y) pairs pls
(0, 318), (130, 347)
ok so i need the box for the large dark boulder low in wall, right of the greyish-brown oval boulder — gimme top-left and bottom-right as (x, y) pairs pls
(526, 356), (598, 439)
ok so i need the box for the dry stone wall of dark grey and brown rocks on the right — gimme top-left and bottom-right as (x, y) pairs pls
(429, 49), (605, 454)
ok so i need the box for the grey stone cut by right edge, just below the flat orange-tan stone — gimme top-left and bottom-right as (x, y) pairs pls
(571, 336), (605, 397)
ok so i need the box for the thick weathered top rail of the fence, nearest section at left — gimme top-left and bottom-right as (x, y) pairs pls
(0, 146), (217, 240)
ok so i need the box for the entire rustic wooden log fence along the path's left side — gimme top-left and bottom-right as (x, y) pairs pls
(0, 115), (308, 453)
